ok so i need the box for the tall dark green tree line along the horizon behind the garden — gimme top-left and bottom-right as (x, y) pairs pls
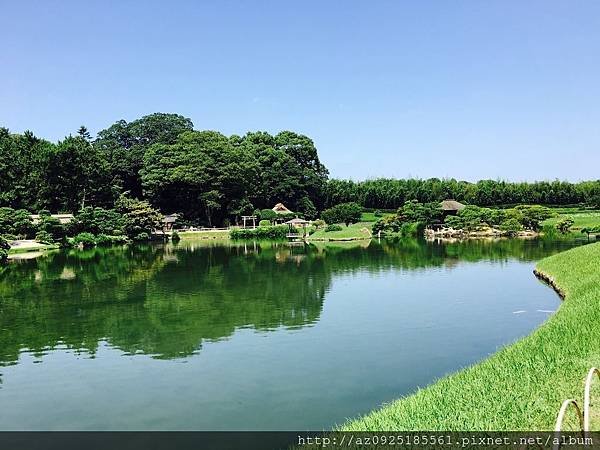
(0, 113), (600, 226)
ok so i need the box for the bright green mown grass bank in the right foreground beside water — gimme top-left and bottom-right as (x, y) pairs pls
(343, 244), (600, 430)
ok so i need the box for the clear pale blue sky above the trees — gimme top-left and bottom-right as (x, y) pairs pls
(0, 0), (600, 181)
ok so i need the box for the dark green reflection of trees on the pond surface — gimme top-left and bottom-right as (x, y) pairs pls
(0, 240), (573, 364)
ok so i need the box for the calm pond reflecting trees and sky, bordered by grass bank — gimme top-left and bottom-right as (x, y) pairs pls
(0, 240), (577, 430)
